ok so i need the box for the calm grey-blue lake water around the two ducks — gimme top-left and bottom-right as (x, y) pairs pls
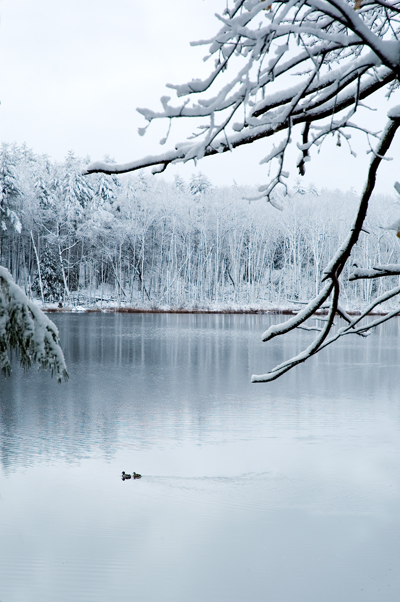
(0, 314), (400, 602)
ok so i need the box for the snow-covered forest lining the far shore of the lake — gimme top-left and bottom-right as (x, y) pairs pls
(0, 144), (400, 310)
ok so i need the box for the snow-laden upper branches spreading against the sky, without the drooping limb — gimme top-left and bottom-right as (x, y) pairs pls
(85, 0), (400, 200)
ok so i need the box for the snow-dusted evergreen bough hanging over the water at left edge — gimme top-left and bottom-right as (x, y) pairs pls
(0, 266), (68, 381)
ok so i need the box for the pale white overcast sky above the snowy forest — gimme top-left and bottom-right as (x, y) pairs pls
(0, 0), (400, 193)
